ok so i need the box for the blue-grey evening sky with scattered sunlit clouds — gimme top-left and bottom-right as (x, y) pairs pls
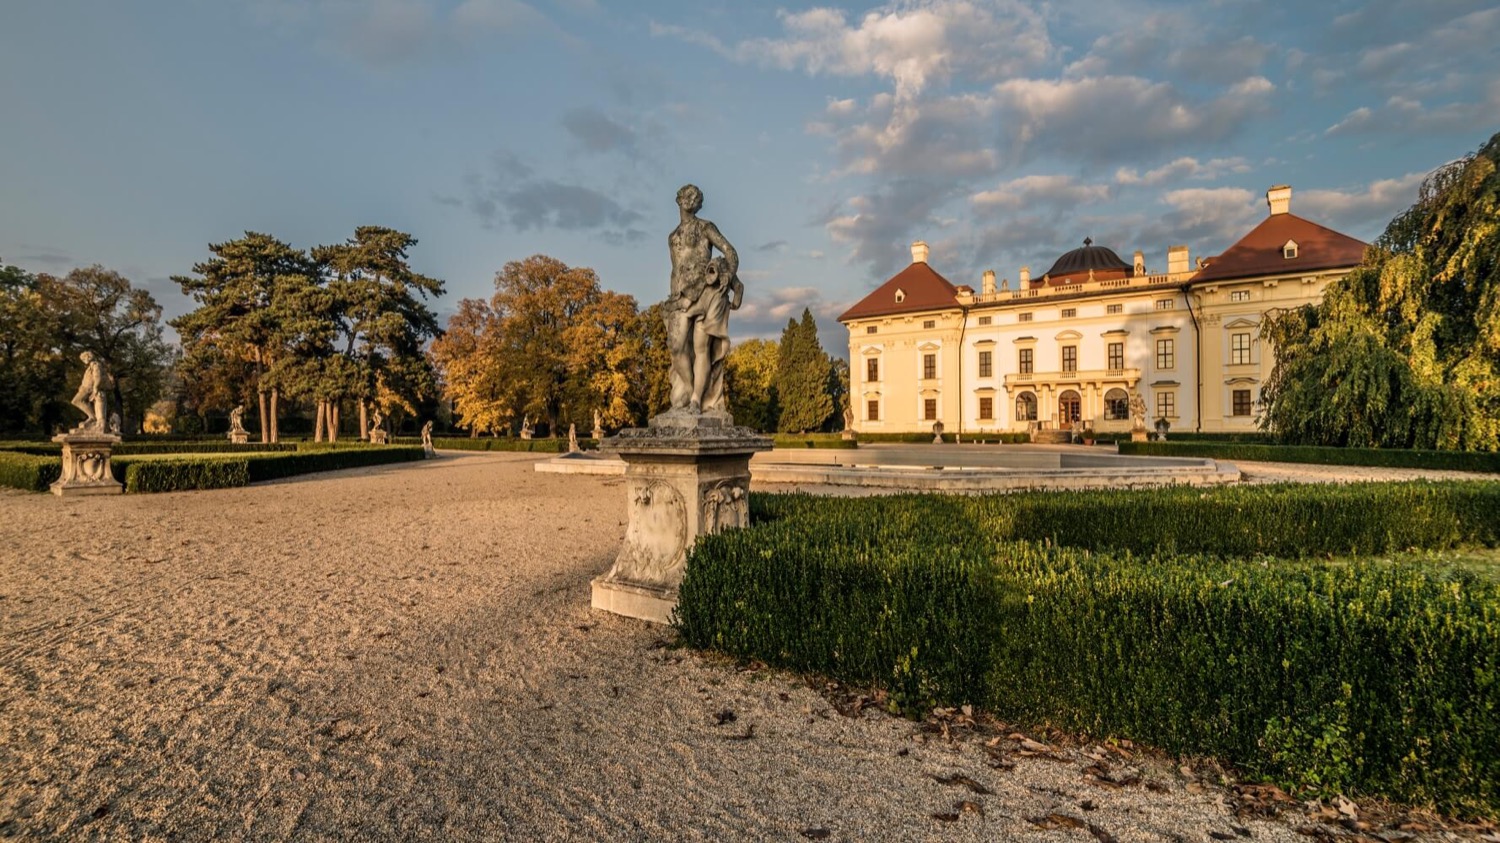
(0, 0), (1500, 353)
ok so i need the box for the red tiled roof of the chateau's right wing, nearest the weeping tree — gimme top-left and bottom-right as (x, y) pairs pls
(1193, 213), (1368, 284)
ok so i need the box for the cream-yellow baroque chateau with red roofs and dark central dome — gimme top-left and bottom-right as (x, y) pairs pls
(839, 186), (1367, 437)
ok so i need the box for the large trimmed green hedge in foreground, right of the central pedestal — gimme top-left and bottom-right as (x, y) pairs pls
(678, 483), (1500, 815)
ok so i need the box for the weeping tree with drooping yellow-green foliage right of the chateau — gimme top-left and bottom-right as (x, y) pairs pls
(1262, 129), (1500, 450)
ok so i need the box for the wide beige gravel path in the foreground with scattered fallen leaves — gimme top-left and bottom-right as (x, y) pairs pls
(0, 455), (1452, 842)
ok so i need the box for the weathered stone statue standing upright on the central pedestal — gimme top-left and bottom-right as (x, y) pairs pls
(666, 185), (744, 414)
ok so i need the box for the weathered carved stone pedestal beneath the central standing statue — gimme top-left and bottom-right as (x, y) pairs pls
(591, 411), (771, 624)
